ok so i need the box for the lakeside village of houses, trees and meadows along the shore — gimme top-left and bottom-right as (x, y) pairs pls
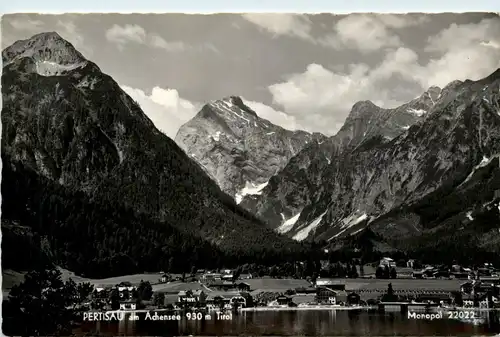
(79, 258), (500, 312)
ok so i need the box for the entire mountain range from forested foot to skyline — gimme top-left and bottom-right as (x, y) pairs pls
(1, 32), (500, 277)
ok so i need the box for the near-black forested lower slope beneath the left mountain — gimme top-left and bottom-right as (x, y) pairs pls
(2, 156), (311, 278)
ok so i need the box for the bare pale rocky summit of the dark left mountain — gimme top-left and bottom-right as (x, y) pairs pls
(2, 32), (87, 70)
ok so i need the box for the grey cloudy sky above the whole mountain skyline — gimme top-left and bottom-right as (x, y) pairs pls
(1, 13), (500, 138)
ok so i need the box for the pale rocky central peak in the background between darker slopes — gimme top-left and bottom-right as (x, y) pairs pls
(175, 96), (326, 203)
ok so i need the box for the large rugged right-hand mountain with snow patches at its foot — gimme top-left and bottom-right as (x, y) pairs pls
(238, 71), (500, 247)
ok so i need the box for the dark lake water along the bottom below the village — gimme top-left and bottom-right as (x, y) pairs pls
(75, 310), (500, 336)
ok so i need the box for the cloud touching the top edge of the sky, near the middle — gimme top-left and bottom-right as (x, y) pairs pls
(242, 13), (313, 40)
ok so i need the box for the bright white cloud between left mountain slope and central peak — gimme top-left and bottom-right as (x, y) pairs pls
(121, 85), (201, 139)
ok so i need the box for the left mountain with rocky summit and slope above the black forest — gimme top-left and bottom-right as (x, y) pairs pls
(2, 33), (300, 264)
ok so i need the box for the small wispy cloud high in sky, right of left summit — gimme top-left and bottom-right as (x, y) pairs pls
(106, 24), (191, 52)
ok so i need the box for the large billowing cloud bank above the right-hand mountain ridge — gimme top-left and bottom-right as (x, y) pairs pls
(268, 19), (500, 134)
